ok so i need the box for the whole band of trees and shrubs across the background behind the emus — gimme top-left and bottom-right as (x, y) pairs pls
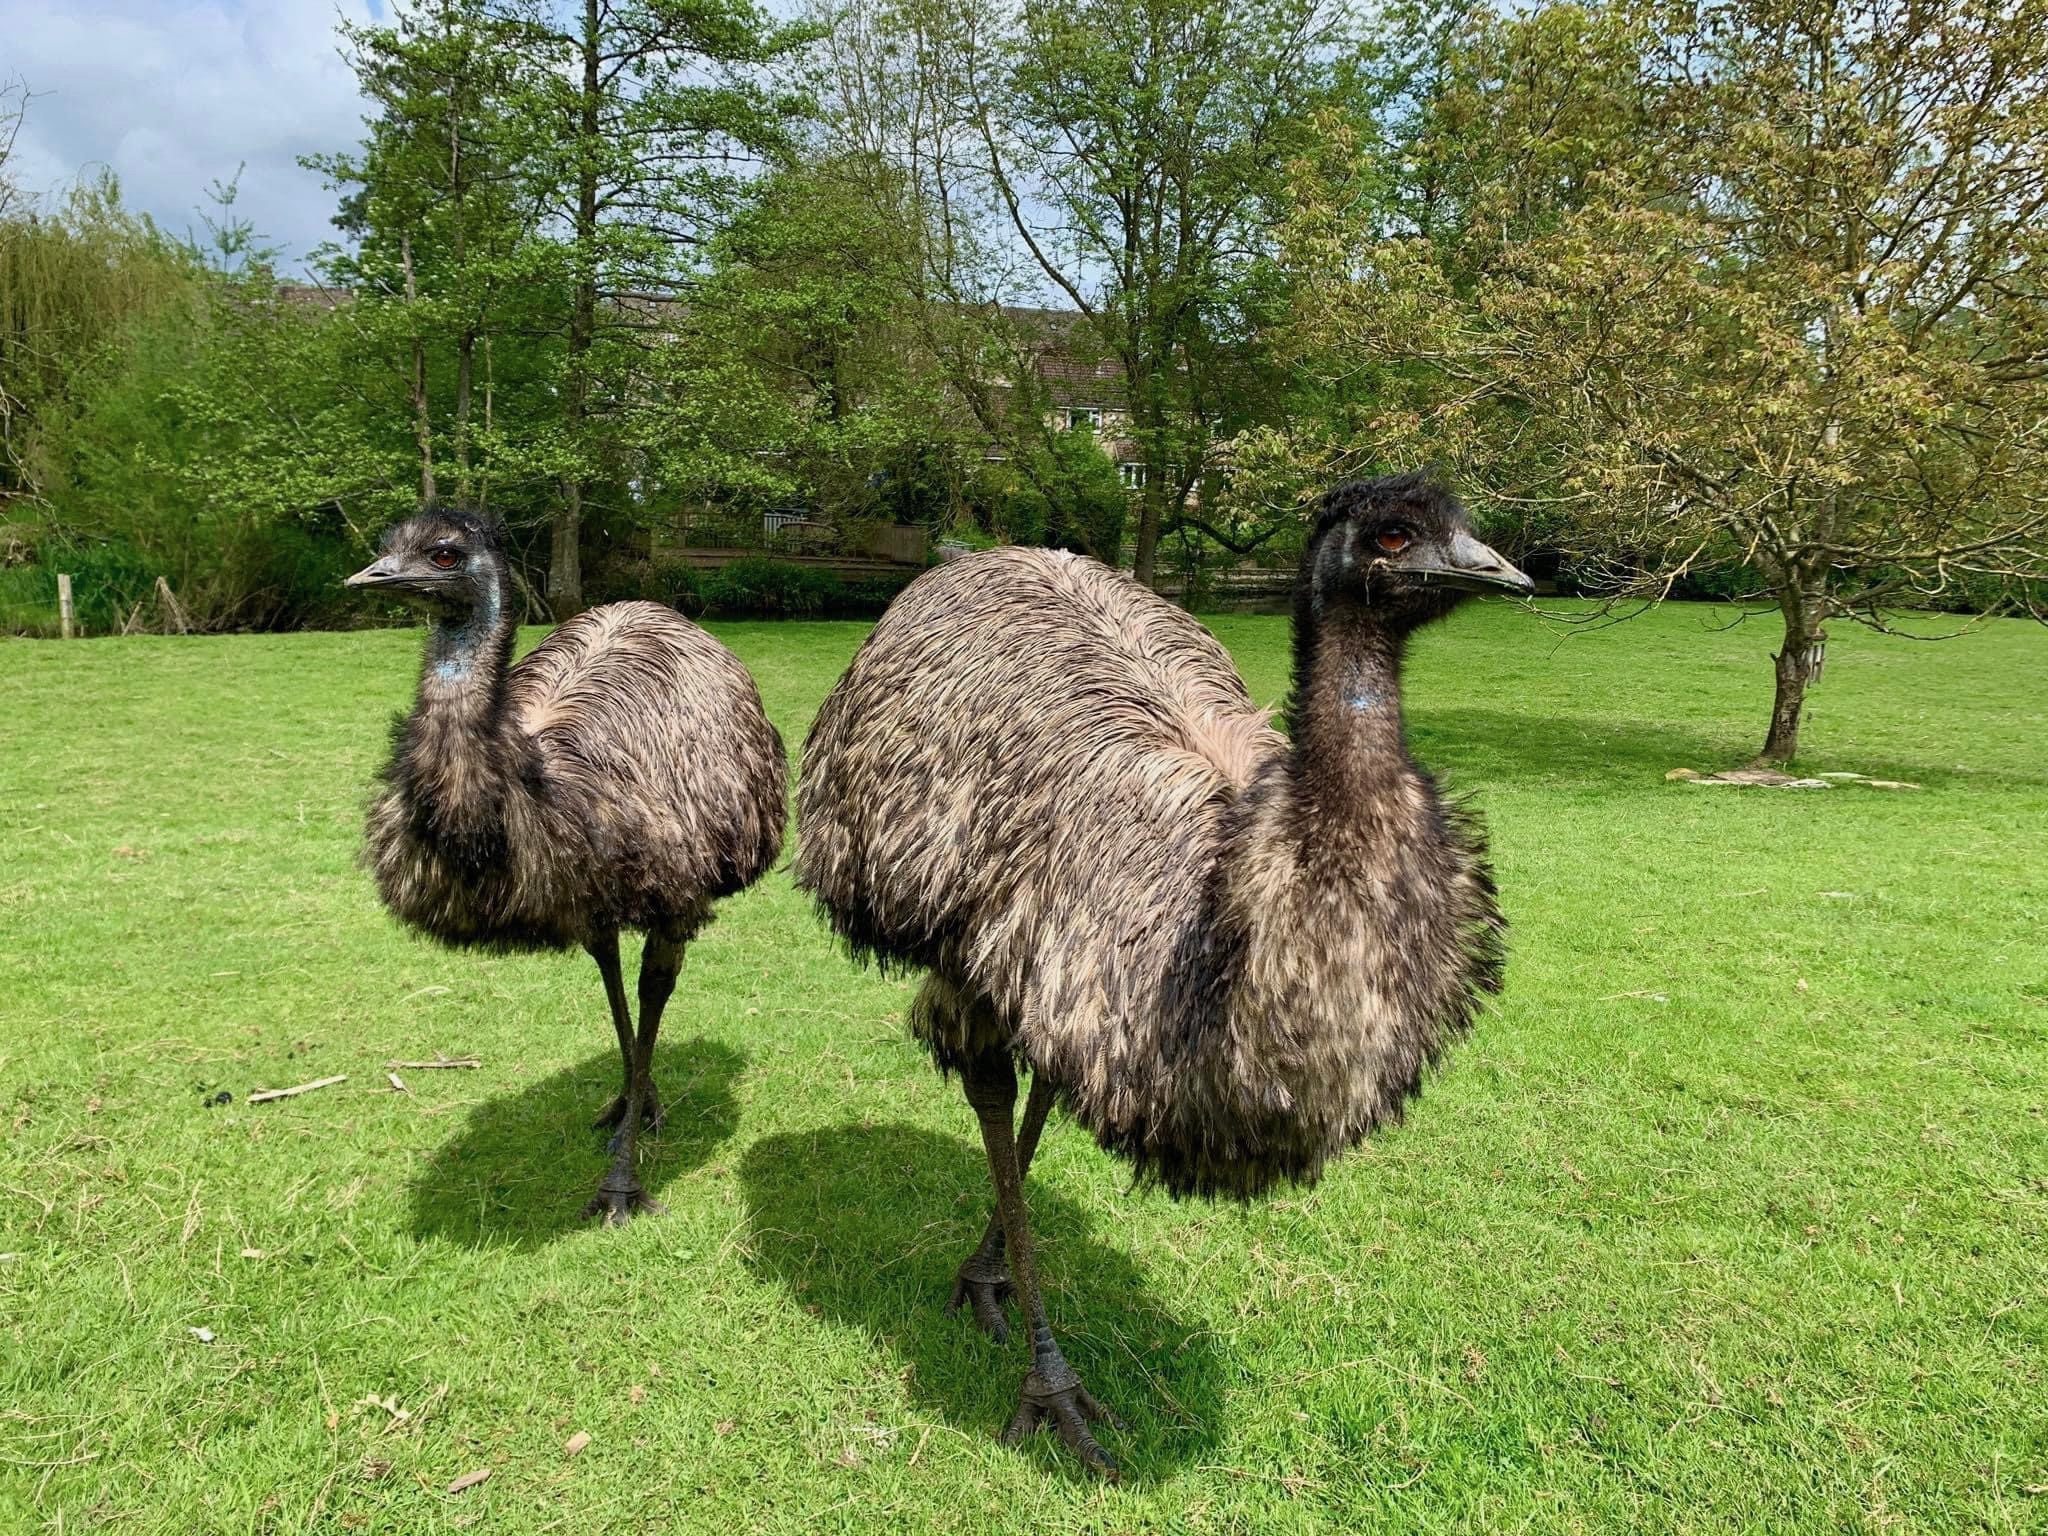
(0, 0), (2048, 758)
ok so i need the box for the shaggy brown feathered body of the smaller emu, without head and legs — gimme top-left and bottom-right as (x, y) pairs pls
(369, 602), (786, 948)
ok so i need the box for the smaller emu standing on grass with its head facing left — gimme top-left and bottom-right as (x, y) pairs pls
(348, 508), (788, 1225)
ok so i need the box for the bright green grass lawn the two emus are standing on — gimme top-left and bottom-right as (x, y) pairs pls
(0, 604), (2048, 1536)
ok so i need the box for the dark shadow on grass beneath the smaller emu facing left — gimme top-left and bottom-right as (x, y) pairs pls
(408, 1038), (748, 1249)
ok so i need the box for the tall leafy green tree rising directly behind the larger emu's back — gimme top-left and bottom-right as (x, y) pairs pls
(961, 0), (1331, 584)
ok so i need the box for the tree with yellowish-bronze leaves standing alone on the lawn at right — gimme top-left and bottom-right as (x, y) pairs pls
(1290, 0), (2048, 762)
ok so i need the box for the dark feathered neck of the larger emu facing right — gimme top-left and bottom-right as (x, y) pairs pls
(1292, 608), (1415, 842)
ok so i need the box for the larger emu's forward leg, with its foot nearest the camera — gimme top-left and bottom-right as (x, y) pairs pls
(961, 1053), (1116, 1481)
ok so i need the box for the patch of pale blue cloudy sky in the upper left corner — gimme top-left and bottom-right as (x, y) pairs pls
(0, 0), (383, 272)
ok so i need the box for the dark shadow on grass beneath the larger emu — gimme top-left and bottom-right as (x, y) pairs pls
(739, 1122), (1223, 1483)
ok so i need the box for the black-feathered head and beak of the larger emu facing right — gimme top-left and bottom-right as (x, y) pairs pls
(1300, 473), (1536, 629)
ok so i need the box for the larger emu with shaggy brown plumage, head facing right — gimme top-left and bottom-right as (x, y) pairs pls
(797, 475), (1530, 1477)
